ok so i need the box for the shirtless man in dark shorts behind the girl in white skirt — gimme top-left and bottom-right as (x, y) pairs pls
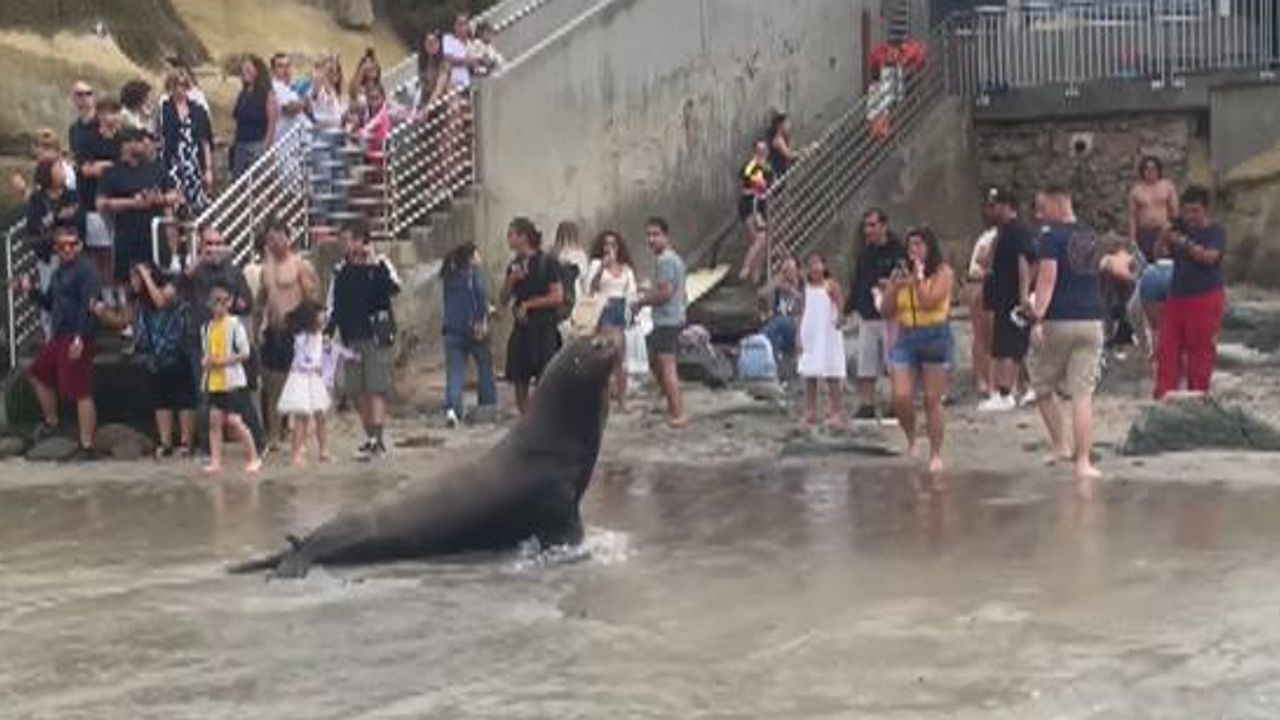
(259, 220), (321, 446)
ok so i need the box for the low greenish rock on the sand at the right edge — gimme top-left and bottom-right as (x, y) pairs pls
(1120, 397), (1280, 455)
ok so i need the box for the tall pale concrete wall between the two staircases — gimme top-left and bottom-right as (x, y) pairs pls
(476, 0), (878, 274)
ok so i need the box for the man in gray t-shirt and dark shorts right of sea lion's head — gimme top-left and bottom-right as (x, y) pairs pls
(640, 218), (689, 429)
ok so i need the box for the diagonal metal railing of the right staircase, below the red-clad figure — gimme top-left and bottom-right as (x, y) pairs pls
(768, 32), (946, 274)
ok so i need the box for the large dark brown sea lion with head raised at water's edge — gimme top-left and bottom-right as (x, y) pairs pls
(228, 337), (618, 578)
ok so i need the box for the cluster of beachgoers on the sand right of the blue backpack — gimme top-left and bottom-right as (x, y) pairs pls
(762, 158), (1225, 479)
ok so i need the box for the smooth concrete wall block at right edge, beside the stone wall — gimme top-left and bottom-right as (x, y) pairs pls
(1210, 83), (1280, 174)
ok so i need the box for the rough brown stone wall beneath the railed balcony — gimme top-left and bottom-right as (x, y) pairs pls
(977, 113), (1204, 232)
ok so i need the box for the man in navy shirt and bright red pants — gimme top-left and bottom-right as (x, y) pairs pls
(1156, 184), (1226, 400)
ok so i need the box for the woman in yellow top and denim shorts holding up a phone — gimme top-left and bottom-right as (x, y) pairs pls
(882, 228), (955, 473)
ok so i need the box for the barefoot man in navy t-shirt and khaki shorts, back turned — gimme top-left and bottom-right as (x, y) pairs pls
(1028, 187), (1106, 480)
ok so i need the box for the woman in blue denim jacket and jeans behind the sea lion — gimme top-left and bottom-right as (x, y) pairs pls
(442, 242), (498, 428)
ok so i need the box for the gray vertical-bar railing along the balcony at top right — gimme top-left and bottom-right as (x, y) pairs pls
(947, 0), (1280, 97)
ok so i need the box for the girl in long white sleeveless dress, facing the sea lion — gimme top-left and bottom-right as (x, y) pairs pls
(796, 252), (846, 427)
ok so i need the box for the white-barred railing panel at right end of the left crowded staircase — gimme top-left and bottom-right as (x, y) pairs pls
(385, 91), (476, 237)
